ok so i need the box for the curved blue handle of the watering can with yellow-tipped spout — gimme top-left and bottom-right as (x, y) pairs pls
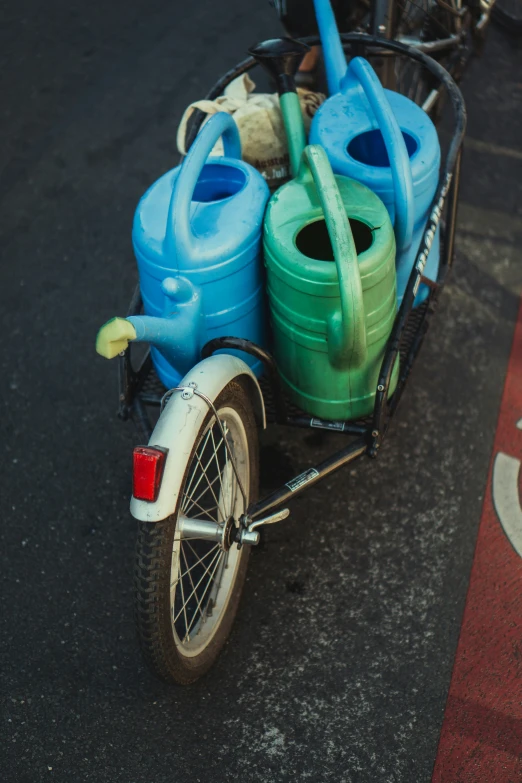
(165, 112), (241, 258)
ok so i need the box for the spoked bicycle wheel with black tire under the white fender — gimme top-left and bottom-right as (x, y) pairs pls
(135, 380), (259, 685)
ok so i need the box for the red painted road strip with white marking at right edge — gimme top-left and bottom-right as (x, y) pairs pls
(432, 301), (522, 783)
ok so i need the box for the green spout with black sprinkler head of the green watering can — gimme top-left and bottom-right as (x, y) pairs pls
(248, 38), (310, 177)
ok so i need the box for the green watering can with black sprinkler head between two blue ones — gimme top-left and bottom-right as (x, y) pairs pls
(250, 38), (399, 420)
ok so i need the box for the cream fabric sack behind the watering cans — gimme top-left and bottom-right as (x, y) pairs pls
(177, 74), (325, 189)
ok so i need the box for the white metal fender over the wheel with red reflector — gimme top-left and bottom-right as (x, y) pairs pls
(130, 354), (266, 522)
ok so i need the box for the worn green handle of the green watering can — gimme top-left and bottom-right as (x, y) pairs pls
(298, 144), (368, 369)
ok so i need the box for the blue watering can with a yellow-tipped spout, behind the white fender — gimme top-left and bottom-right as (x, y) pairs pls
(119, 112), (270, 388)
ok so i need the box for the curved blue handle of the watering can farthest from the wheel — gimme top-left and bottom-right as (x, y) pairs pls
(341, 57), (414, 252)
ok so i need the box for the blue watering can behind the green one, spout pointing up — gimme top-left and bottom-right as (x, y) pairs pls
(310, 0), (440, 305)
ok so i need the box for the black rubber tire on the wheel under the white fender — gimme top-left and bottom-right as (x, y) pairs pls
(135, 379), (259, 685)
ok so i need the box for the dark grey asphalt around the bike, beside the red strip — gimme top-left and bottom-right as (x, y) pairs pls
(0, 0), (522, 783)
